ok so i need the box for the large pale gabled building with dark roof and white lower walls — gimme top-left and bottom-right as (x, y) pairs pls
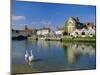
(67, 17), (96, 37)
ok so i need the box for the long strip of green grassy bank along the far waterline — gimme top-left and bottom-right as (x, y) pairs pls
(28, 36), (96, 43)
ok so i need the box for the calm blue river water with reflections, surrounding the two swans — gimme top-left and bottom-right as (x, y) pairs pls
(11, 40), (96, 73)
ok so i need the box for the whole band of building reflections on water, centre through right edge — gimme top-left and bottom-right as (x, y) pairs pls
(26, 40), (95, 64)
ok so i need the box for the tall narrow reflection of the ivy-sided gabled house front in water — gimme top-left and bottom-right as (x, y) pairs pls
(63, 44), (80, 64)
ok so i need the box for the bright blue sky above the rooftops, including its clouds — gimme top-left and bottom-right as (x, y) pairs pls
(11, 1), (96, 29)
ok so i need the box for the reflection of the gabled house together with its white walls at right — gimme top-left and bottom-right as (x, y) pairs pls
(63, 44), (95, 64)
